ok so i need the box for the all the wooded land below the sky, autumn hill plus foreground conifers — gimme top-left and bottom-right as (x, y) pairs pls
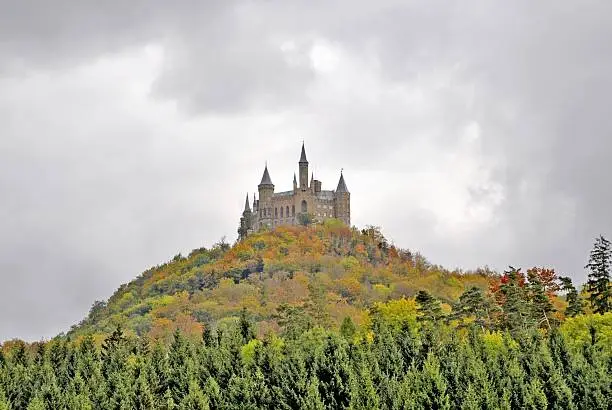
(0, 221), (612, 410)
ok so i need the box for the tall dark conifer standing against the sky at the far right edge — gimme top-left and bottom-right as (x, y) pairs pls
(585, 236), (612, 313)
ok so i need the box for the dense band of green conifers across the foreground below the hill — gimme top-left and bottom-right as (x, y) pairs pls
(0, 314), (612, 410)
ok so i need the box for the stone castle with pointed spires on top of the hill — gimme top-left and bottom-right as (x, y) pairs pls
(238, 144), (351, 239)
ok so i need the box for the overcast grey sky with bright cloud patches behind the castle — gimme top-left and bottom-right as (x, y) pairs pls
(0, 0), (612, 340)
